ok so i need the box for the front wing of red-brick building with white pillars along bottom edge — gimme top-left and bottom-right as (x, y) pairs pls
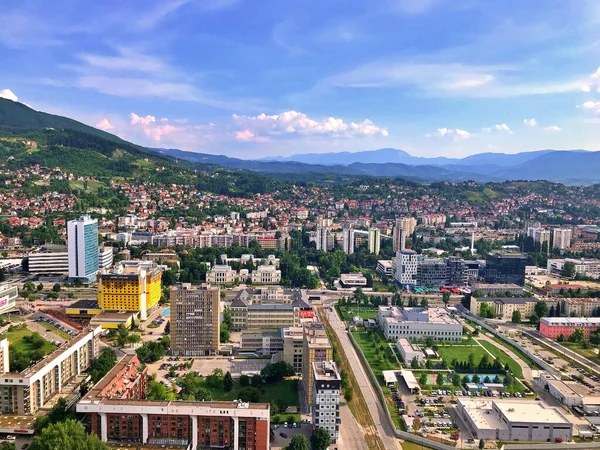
(77, 398), (270, 450)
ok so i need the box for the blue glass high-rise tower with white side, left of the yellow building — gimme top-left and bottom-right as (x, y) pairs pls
(67, 215), (98, 281)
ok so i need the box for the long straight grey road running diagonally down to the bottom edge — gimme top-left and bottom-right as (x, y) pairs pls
(324, 300), (402, 449)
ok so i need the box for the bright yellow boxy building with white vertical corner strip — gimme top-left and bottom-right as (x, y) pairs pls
(98, 261), (162, 320)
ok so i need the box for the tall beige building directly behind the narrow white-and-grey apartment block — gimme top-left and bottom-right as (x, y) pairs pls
(301, 322), (333, 408)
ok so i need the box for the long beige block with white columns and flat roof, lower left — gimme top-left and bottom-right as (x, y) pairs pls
(0, 327), (102, 416)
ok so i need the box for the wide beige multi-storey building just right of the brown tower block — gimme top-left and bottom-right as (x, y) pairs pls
(230, 286), (314, 331)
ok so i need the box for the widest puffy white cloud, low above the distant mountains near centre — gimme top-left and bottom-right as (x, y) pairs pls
(233, 111), (388, 136)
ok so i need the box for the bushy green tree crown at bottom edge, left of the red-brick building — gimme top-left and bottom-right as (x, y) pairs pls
(29, 419), (108, 450)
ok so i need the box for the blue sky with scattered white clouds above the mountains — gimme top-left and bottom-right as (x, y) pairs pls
(0, 0), (600, 159)
